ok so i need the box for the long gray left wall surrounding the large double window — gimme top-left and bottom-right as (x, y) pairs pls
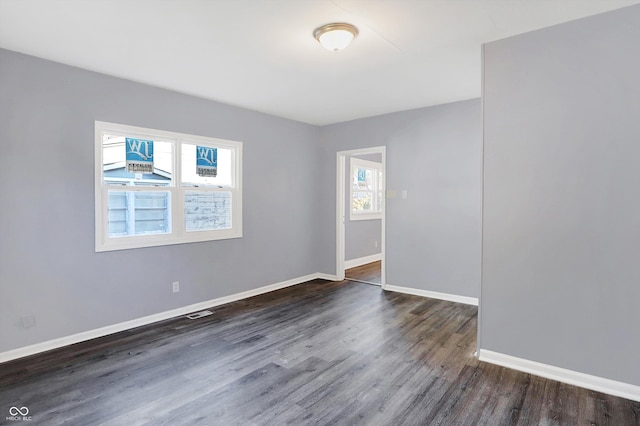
(0, 50), (320, 352)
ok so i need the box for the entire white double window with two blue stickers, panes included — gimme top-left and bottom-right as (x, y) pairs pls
(95, 121), (242, 251)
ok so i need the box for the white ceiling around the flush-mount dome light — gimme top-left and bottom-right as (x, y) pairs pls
(0, 0), (640, 125)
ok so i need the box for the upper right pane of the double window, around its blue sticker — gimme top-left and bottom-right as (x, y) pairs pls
(181, 143), (234, 188)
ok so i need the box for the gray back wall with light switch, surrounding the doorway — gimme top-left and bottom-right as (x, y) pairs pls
(319, 99), (482, 297)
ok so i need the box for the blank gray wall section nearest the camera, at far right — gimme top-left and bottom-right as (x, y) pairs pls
(480, 6), (640, 385)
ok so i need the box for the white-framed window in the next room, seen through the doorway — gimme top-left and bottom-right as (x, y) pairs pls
(349, 157), (383, 220)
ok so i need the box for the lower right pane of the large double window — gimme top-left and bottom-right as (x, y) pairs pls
(184, 191), (231, 232)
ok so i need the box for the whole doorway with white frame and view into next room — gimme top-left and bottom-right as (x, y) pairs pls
(336, 146), (386, 289)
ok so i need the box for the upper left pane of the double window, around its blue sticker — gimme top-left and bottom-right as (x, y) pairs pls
(102, 134), (173, 186)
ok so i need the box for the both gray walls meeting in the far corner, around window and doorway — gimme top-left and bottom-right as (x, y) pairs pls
(0, 49), (481, 352)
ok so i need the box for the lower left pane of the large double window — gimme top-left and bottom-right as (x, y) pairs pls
(108, 191), (171, 237)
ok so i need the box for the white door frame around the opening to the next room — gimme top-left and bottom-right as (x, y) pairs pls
(336, 146), (387, 289)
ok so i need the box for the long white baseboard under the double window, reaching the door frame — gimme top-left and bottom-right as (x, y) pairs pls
(0, 273), (320, 363)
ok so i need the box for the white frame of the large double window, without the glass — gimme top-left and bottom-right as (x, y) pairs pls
(94, 121), (242, 252)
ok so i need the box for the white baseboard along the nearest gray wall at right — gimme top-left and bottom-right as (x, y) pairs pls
(478, 349), (640, 401)
